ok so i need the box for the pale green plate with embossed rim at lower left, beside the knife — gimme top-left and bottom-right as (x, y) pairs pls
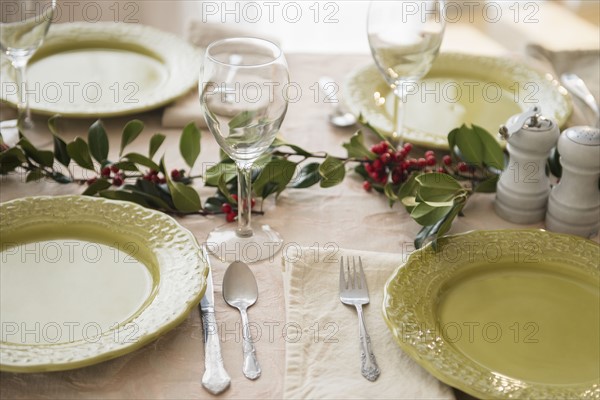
(0, 196), (208, 372)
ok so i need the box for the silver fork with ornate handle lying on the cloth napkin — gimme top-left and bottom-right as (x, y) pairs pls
(340, 257), (380, 382)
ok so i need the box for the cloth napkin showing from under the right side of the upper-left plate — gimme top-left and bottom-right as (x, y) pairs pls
(162, 21), (277, 128)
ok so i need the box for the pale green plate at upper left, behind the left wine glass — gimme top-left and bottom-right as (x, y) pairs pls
(0, 22), (201, 117)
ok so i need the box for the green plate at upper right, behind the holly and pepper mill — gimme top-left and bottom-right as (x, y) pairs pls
(344, 53), (572, 149)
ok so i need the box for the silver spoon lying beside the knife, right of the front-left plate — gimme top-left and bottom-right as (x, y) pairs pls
(223, 261), (261, 379)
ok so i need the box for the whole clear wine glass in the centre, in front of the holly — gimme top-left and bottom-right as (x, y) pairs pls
(199, 38), (289, 262)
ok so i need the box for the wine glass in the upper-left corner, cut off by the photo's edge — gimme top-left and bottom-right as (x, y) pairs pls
(0, 0), (56, 131)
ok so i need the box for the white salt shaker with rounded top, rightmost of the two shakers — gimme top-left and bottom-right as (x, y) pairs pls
(546, 126), (600, 237)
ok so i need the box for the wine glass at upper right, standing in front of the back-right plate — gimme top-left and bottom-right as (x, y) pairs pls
(367, 0), (446, 141)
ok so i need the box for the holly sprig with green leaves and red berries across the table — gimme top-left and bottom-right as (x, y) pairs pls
(0, 117), (505, 248)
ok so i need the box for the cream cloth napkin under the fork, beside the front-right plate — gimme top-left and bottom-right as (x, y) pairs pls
(284, 248), (454, 399)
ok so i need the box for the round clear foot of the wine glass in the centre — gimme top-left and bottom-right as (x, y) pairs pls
(206, 223), (283, 263)
